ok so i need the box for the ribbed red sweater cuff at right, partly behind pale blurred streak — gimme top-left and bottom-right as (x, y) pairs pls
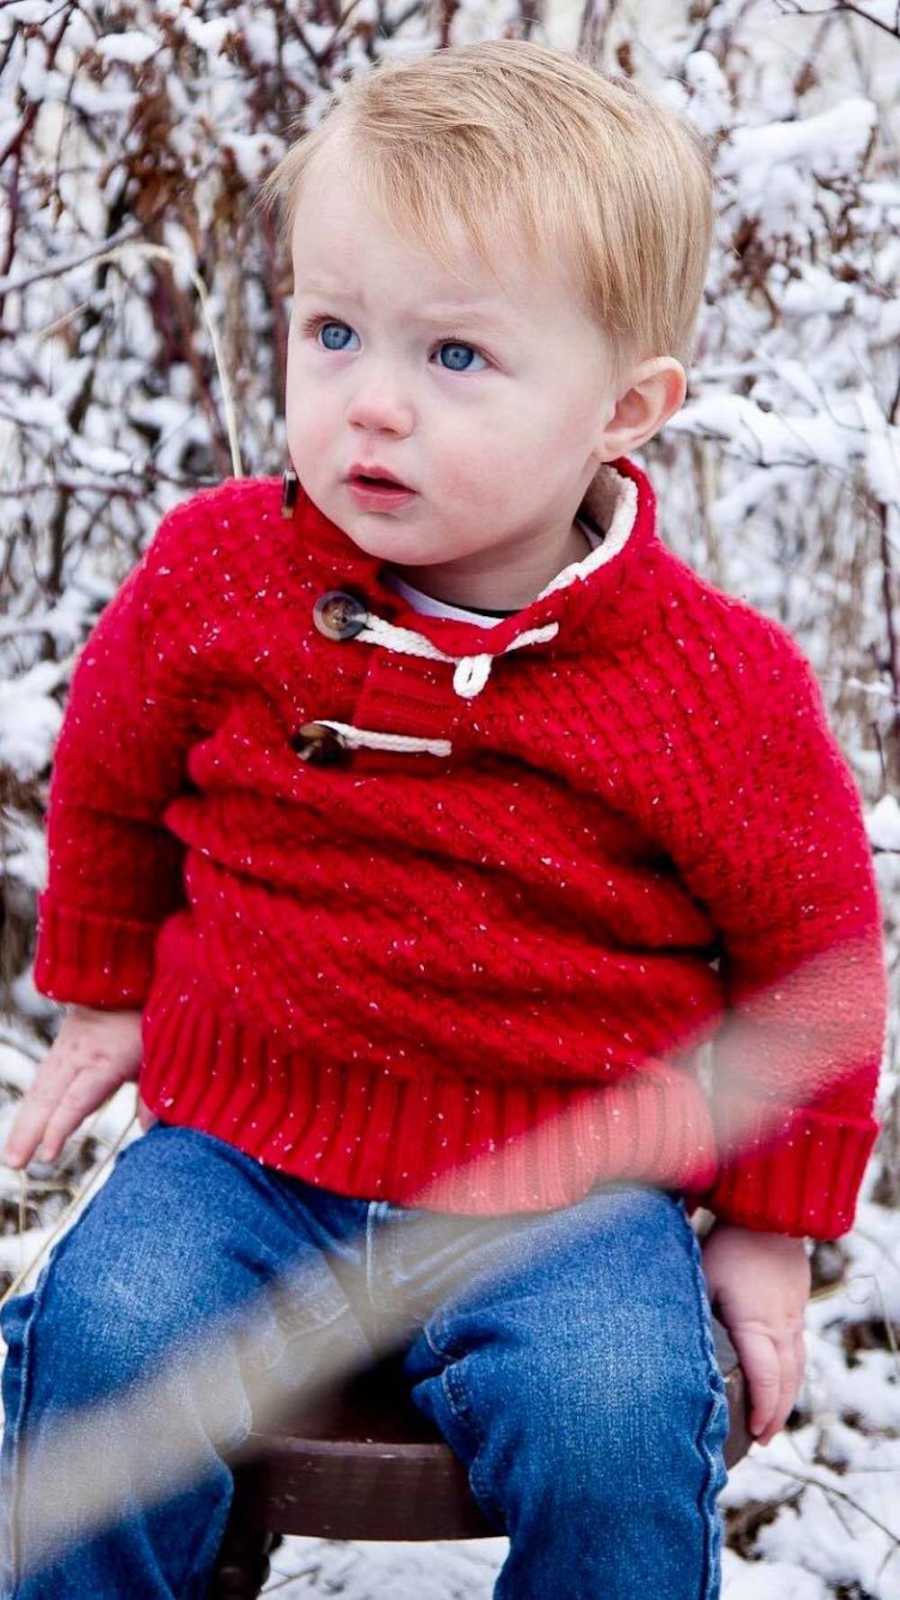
(698, 1094), (881, 1238)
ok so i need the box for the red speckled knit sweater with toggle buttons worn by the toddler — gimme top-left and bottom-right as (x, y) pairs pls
(35, 458), (886, 1238)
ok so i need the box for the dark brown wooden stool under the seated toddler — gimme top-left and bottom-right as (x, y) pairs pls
(208, 1318), (753, 1600)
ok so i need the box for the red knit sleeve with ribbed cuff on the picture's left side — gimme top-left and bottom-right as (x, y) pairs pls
(34, 512), (194, 1010)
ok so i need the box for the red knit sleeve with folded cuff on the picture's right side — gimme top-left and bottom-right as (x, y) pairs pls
(666, 622), (887, 1238)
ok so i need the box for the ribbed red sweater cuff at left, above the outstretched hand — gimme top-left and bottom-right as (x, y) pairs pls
(34, 890), (159, 1011)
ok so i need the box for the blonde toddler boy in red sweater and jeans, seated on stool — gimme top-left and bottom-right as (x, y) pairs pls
(0, 40), (884, 1600)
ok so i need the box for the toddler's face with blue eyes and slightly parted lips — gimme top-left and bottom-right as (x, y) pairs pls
(287, 149), (627, 606)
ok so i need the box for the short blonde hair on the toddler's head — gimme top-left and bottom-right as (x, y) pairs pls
(259, 38), (714, 384)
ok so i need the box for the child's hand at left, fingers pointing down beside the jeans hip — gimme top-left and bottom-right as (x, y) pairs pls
(0, 1006), (145, 1166)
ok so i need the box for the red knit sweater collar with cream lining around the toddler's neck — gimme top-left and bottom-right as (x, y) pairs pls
(295, 456), (661, 698)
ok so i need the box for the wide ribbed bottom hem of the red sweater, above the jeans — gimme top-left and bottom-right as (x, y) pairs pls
(141, 974), (716, 1216)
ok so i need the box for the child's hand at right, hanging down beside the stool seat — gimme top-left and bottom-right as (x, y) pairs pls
(701, 1222), (812, 1445)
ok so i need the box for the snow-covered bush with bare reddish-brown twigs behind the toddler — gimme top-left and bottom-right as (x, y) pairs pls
(0, 0), (900, 1600)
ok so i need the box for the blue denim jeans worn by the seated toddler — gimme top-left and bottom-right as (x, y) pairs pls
(0, 1123), (729, 1600)
